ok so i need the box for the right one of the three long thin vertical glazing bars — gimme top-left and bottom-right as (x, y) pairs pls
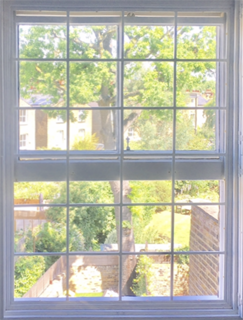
(170, 11), (177, 300)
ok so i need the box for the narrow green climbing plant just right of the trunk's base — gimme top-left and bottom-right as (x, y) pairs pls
(131, 255), (153, 296)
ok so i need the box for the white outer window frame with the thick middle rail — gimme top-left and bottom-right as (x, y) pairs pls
(0, 0), (243, 319)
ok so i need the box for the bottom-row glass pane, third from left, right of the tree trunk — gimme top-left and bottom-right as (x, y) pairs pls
(122, 255), (171, 300)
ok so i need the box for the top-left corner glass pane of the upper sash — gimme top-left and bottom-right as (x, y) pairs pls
(19, 25), (67, 59)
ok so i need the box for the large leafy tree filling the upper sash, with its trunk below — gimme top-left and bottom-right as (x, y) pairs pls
(20, 25), (216, 294)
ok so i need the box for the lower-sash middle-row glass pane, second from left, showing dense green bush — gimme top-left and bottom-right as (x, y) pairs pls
(69, 206), (120, 251)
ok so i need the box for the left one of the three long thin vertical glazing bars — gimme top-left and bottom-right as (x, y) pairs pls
(66, 11), (70, 300)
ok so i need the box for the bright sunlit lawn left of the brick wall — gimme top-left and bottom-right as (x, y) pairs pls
(144, 211), (191, 247)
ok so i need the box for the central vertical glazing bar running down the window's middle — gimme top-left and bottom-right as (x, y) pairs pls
(119, 11), (124, 301)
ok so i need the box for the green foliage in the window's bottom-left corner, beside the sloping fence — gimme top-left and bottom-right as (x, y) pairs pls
(14, 256), (45, 298)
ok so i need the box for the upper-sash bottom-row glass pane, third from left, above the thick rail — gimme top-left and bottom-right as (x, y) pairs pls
(123, 109), (173, 151)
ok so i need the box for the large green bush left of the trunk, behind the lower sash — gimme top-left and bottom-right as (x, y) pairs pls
(47, 182), (115, 250)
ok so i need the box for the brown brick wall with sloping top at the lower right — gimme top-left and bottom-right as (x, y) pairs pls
(189, 206), (219, 296)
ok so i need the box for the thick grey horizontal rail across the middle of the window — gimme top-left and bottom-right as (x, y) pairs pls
(15, 160), (224, 182)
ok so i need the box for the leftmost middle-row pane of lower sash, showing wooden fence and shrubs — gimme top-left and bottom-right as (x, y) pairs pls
(14, 207), (66, 252)
